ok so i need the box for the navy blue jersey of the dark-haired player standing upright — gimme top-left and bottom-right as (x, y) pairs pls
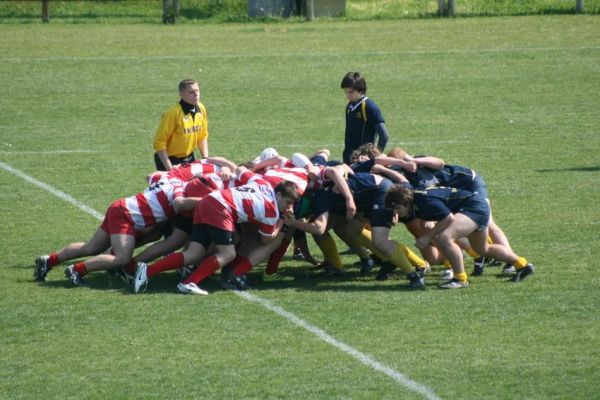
(343, 97), (385, 164)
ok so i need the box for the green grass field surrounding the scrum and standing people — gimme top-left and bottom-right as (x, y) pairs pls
(0, 16), (600, 399)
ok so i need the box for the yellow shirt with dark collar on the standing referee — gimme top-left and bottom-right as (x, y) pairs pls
(154, 103), (208, 158)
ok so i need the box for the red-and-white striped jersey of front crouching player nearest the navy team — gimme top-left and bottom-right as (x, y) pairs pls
(209, 171), (279, 236)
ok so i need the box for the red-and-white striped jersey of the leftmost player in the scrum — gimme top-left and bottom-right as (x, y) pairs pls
(125, 180), (184, 229)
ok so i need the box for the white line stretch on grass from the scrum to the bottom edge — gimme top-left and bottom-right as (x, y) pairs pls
(234, 292), (440, 400)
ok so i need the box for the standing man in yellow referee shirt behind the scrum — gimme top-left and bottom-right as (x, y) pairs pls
(154, 79), (208, 171)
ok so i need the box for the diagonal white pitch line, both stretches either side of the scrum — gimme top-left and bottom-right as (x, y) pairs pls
(0, 162), (441, 400)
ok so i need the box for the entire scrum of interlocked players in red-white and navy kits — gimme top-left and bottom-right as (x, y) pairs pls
(34, 145), (535, 295)
